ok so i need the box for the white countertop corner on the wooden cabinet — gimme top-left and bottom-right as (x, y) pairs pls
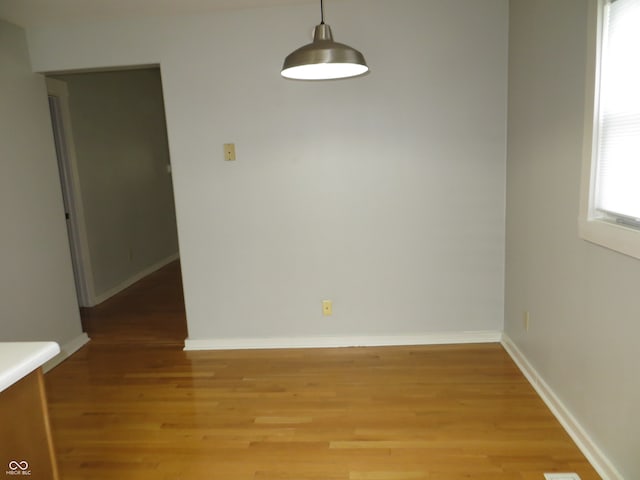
(0, 342), (60, 392)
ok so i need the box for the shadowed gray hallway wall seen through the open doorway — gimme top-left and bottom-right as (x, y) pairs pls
(55, 69), (178, 300)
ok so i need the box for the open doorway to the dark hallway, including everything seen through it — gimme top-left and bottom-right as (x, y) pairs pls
(47, 67), (187, 343)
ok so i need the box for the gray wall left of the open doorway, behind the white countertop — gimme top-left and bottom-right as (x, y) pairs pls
(0, 21), (82, 344)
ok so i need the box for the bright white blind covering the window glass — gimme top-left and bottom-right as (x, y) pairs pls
(594, 0), (640, 221)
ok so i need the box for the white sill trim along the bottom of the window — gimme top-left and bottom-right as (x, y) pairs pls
(578, 218), (640, 259)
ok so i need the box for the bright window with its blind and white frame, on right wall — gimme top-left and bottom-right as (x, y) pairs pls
(580, 0), (640, 258)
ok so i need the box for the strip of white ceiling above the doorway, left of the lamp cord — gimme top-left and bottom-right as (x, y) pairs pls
(0, 0), (320, 27)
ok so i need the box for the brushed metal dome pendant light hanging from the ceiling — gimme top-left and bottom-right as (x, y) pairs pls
(280, 0), (369, 80)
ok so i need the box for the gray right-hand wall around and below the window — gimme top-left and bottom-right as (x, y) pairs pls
(505, 0), (640, 479)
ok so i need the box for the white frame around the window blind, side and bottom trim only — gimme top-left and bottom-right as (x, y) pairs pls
(578, 0), (640, 259)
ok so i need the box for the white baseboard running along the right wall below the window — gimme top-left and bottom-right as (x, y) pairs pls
(502, 333), (624, 480)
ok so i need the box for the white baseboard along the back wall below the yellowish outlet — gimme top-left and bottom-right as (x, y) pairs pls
(184, 331), (502, 350)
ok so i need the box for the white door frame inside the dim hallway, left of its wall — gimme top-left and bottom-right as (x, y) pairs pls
(46, 78), (96, 307)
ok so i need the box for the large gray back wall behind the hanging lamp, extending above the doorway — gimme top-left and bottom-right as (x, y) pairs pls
(29, 0), (508, 343)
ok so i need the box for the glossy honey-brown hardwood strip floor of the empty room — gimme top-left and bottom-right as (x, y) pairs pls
(46, 264), (600, 480)
